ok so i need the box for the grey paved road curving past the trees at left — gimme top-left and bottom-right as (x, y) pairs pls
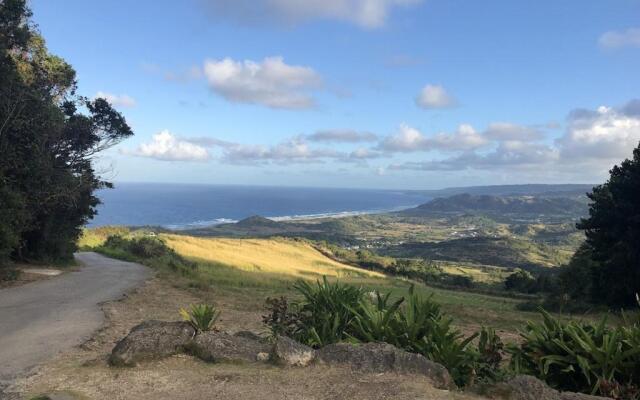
(0, 253), (150, 384)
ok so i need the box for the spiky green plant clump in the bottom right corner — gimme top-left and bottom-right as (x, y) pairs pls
(508, 311), (640, 398)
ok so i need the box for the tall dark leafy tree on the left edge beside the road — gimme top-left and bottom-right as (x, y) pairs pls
(0, 0), (133, 263)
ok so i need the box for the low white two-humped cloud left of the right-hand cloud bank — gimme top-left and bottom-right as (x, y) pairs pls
(379, 124), (488, 152)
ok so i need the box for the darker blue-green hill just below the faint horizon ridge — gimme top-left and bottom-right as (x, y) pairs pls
(402, 193), (587, 216)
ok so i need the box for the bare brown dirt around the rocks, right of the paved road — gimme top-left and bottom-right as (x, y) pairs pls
(9, 278), (480, 400)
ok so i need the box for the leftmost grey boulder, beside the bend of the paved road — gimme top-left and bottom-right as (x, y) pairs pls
(109, 321), (196, 366)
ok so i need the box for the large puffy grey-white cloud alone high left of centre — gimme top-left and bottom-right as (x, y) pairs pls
(204, 57), (322, 109)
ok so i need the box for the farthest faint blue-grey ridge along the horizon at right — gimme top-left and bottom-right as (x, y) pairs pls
(410, 184), (595, 197)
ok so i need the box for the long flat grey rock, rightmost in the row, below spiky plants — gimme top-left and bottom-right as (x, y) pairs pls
(318, 343), (455, 389)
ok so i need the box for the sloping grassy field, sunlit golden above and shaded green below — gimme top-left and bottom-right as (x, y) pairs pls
(80, 228), (537, 334)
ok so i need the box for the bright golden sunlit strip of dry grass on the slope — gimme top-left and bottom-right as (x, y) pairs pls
(162, 234), (384, 278)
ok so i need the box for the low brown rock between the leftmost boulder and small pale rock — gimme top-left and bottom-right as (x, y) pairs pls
(186, 331), (269, 362)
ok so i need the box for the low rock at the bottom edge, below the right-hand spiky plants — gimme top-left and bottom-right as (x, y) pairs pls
(488, 375), (607, 400)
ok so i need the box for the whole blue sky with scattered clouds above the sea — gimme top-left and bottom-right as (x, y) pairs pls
(31, 0), (640, 189)
